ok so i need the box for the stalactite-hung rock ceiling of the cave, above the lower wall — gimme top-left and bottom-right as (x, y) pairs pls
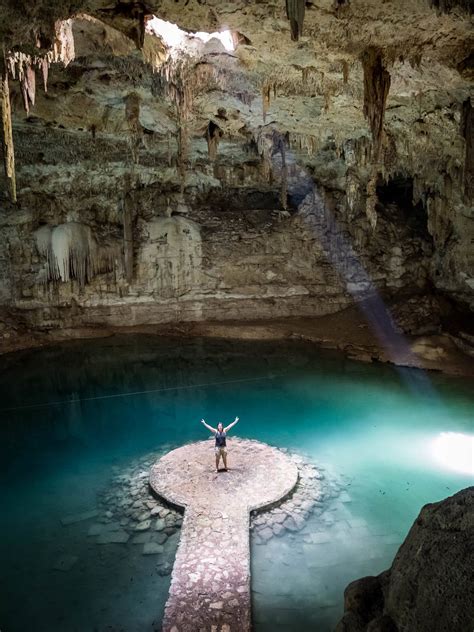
(0, 0), (474, 326)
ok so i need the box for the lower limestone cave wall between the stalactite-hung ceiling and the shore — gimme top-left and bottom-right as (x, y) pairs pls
(0, 173), (431, 327)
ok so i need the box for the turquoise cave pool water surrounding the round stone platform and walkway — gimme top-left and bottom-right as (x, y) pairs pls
(0, 336), (474, 632)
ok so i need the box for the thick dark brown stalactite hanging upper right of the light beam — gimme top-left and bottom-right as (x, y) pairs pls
(362, 47), (391, 161)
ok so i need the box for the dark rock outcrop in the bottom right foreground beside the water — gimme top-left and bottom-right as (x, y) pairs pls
(336, 487), (474, 632)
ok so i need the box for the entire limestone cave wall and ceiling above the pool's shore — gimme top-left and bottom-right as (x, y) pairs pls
(0, 0), (474, 327)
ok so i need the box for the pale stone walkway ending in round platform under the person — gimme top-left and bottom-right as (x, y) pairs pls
(150, 438), (298, 632)
